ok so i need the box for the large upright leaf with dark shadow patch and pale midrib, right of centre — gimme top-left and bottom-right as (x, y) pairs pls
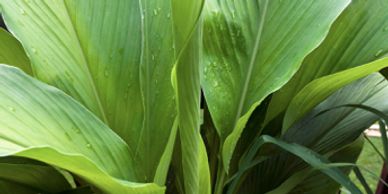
(202, 0), (350, 171)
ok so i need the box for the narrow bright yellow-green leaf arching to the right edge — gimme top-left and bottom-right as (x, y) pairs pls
(283, 58), (388, 132)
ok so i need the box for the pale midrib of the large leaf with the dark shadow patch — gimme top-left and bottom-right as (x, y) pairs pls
(232, 0), (268, 135)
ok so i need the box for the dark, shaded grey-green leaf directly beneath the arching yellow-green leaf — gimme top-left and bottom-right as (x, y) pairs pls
(283, 73), (388, 153)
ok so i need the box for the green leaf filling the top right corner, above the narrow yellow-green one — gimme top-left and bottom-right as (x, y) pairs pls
(266, 0), (388, 126)
